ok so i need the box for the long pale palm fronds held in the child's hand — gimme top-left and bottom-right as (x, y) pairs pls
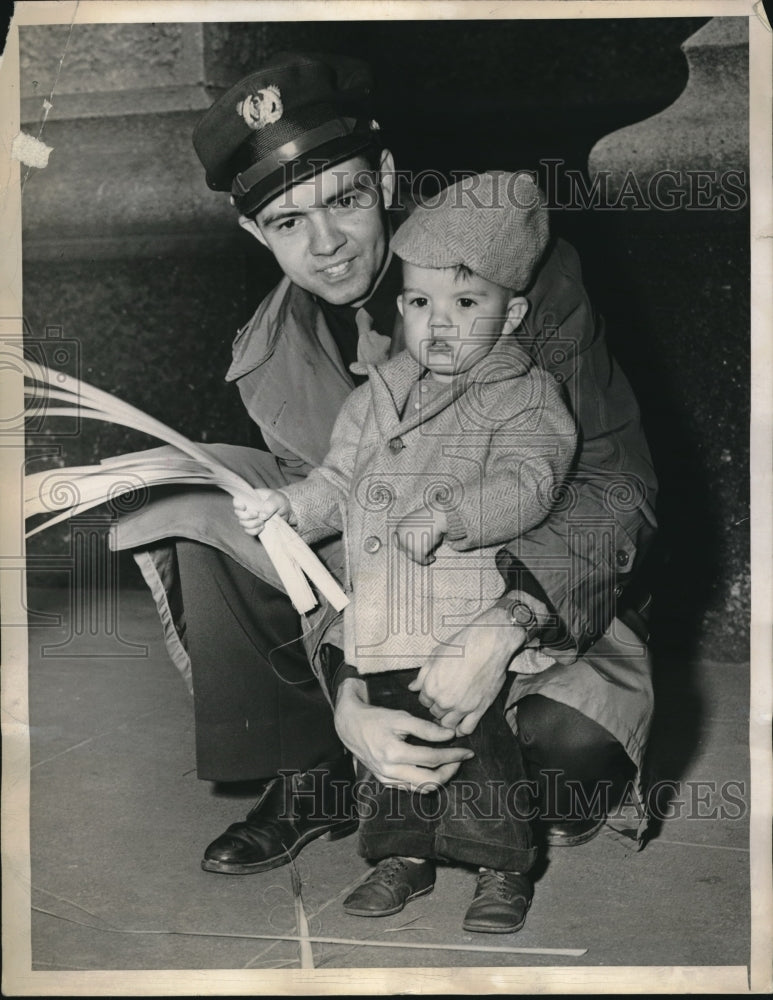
(24, 361), (349, 614)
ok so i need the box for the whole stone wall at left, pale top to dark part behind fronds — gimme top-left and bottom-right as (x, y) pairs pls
(20, 23), (276, 580)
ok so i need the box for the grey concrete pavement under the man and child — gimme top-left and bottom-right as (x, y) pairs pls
(22, 588), (749, 971)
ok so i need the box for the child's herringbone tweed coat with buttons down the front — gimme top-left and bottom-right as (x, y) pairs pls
(284, 337), (577, 673)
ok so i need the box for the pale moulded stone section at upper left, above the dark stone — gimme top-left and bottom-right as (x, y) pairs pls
(20, 24), (235, 261)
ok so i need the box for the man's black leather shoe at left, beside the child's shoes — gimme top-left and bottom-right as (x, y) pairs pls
(201, 755), (357, 875)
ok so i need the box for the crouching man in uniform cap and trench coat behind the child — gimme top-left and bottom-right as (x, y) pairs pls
(118, 53), (656, 929)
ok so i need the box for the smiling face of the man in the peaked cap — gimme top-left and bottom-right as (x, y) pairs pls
(255, 154), (391, 305)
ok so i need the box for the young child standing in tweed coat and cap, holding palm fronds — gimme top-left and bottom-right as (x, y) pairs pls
(235, 173), (576, 933)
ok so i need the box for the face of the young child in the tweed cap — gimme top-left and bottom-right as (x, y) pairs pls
(398, 263), (511, 381)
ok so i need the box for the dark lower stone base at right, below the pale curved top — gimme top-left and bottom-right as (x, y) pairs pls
(578, 213), (750, 660)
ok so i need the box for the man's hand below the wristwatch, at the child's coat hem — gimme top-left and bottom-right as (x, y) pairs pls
(410, 608), (527, 736)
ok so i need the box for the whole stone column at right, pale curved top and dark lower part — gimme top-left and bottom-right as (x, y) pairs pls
(589, 17), (750, 659)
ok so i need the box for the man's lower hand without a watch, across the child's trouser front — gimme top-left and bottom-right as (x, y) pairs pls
(335, 677), (474, 792)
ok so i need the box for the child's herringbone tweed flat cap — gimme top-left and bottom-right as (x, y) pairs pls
(390, 171), (549, 291)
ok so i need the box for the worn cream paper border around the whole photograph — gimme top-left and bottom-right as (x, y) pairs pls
(0, 0), (773, 996)
